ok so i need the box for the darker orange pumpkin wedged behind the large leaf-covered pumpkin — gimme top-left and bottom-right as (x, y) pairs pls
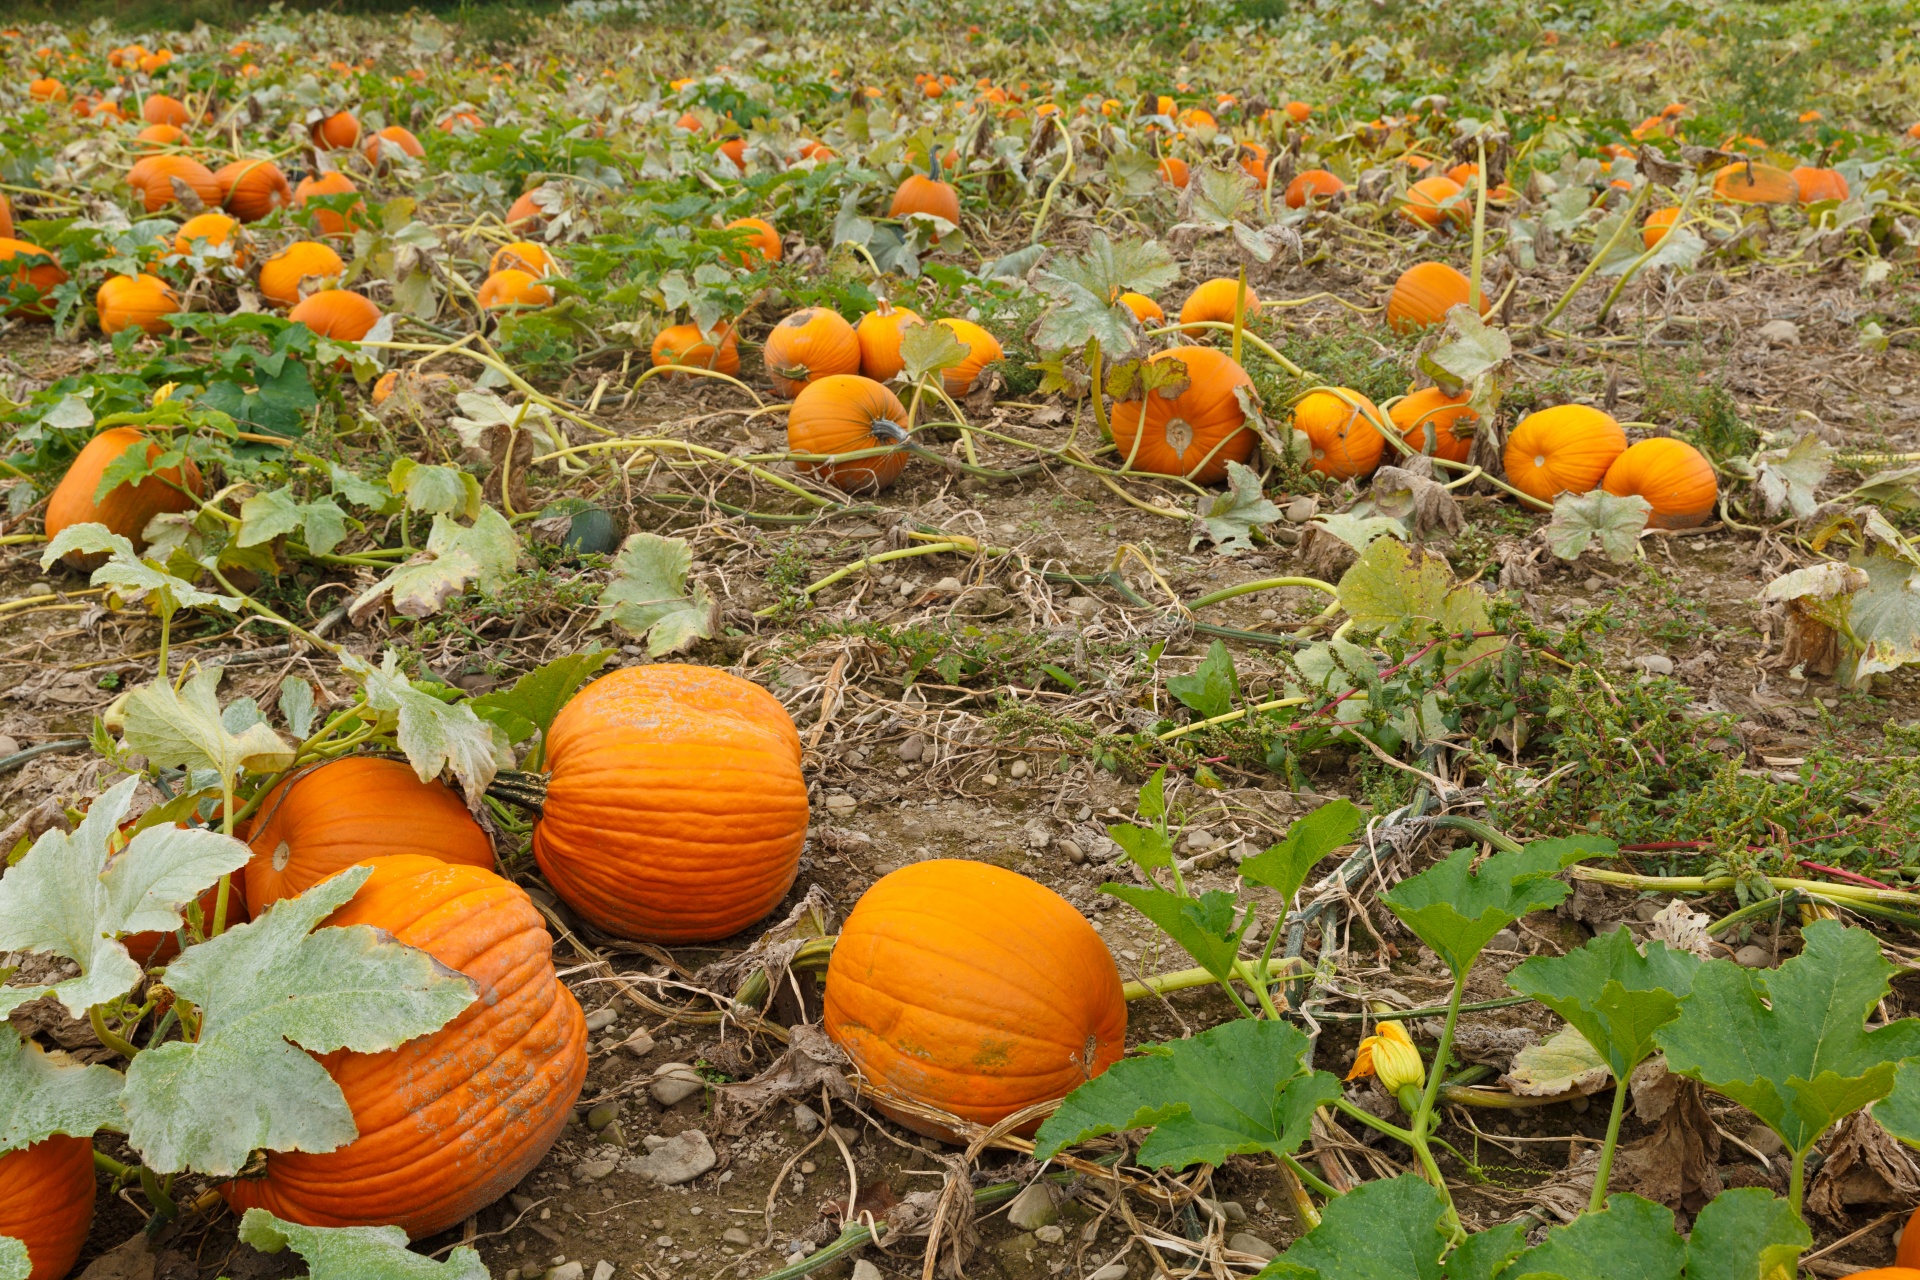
(240, 756), (493, 912)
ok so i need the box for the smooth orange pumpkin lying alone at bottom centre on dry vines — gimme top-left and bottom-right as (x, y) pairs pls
(822, 858), (1127, 1142)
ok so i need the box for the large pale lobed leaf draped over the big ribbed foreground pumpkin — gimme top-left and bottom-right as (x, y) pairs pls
(125, 867), (476, 1176)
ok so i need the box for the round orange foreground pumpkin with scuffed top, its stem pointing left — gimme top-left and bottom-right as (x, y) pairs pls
(534, 662), (808, 944)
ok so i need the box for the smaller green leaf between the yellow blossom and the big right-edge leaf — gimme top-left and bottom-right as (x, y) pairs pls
(1507, 925), (1699, 1080)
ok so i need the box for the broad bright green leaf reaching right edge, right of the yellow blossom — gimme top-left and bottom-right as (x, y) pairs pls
(1655, 919), (1920, 1151)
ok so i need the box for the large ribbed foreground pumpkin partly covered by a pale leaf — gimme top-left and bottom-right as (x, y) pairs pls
(221, 856), (588, 1240)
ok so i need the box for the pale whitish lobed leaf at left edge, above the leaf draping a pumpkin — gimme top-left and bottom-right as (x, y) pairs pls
(0, 777), (252, 1017)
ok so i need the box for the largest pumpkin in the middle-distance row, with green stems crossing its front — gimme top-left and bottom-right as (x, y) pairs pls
(1110, 347), (1258, 484)
